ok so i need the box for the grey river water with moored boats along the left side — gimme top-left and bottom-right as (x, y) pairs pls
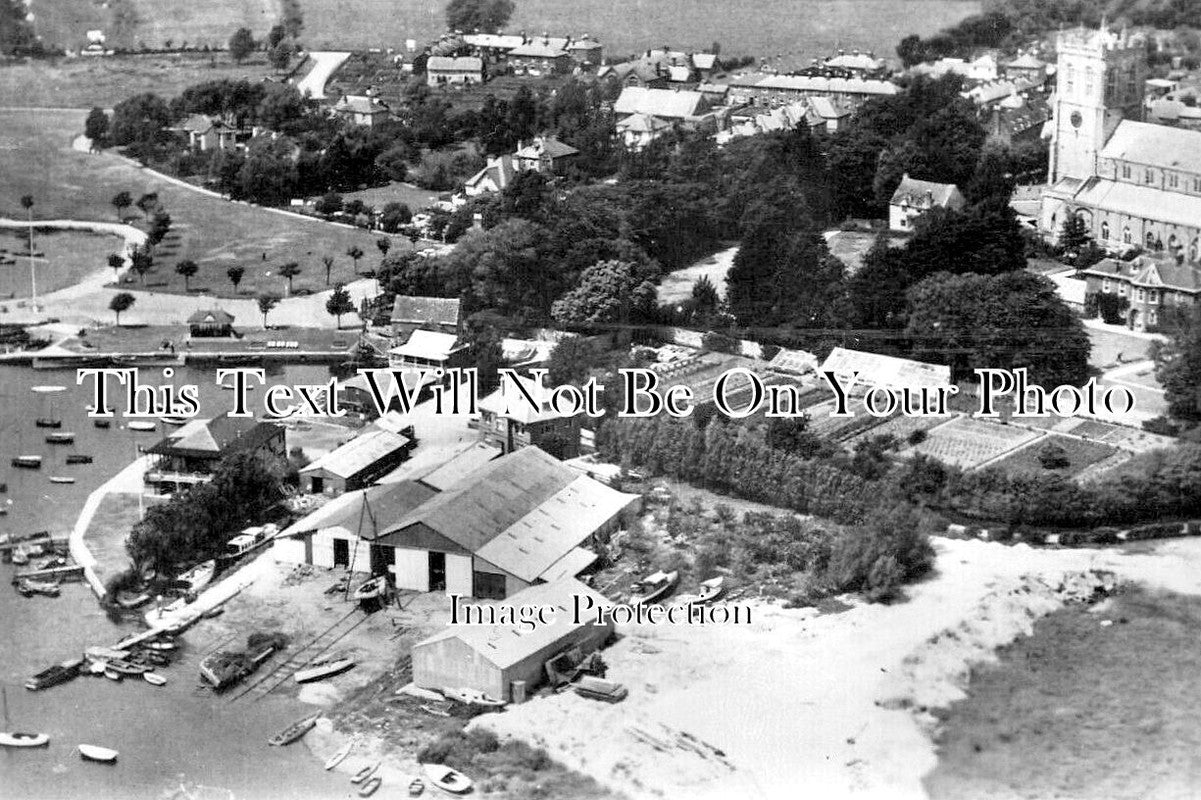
(0, 366), (355, 800)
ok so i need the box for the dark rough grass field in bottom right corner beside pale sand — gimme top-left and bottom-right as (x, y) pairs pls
(925, 578), (1201, 800)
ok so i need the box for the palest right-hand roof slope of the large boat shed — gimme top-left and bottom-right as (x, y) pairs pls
(476, 474), (638, 581)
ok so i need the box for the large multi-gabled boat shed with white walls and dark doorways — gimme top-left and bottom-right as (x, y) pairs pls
(275, 447), (640, 598)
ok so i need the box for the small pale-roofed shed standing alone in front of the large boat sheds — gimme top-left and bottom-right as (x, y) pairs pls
(413, 578), (614, 703)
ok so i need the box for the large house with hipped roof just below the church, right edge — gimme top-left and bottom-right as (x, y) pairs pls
(1082, 255), (1201, 330)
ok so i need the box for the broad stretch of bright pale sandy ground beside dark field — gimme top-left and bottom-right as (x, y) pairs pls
(474, 539), (1201, 799)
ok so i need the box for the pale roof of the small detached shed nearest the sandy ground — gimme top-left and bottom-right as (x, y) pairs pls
(413, 578), (609, 669)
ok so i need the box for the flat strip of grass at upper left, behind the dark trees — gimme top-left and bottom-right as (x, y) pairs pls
(0, 54), (275, 109)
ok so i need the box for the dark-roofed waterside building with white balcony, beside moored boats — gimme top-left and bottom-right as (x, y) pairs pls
(145, 416), (287, 494)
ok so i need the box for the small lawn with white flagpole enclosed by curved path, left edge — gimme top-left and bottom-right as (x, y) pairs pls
(0, 228), (117, 299)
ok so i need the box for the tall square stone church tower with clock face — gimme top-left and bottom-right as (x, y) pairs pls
(1047, 24), (1147, 186)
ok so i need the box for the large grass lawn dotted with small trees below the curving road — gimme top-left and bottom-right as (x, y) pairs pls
(0, 109), (396, 297)
